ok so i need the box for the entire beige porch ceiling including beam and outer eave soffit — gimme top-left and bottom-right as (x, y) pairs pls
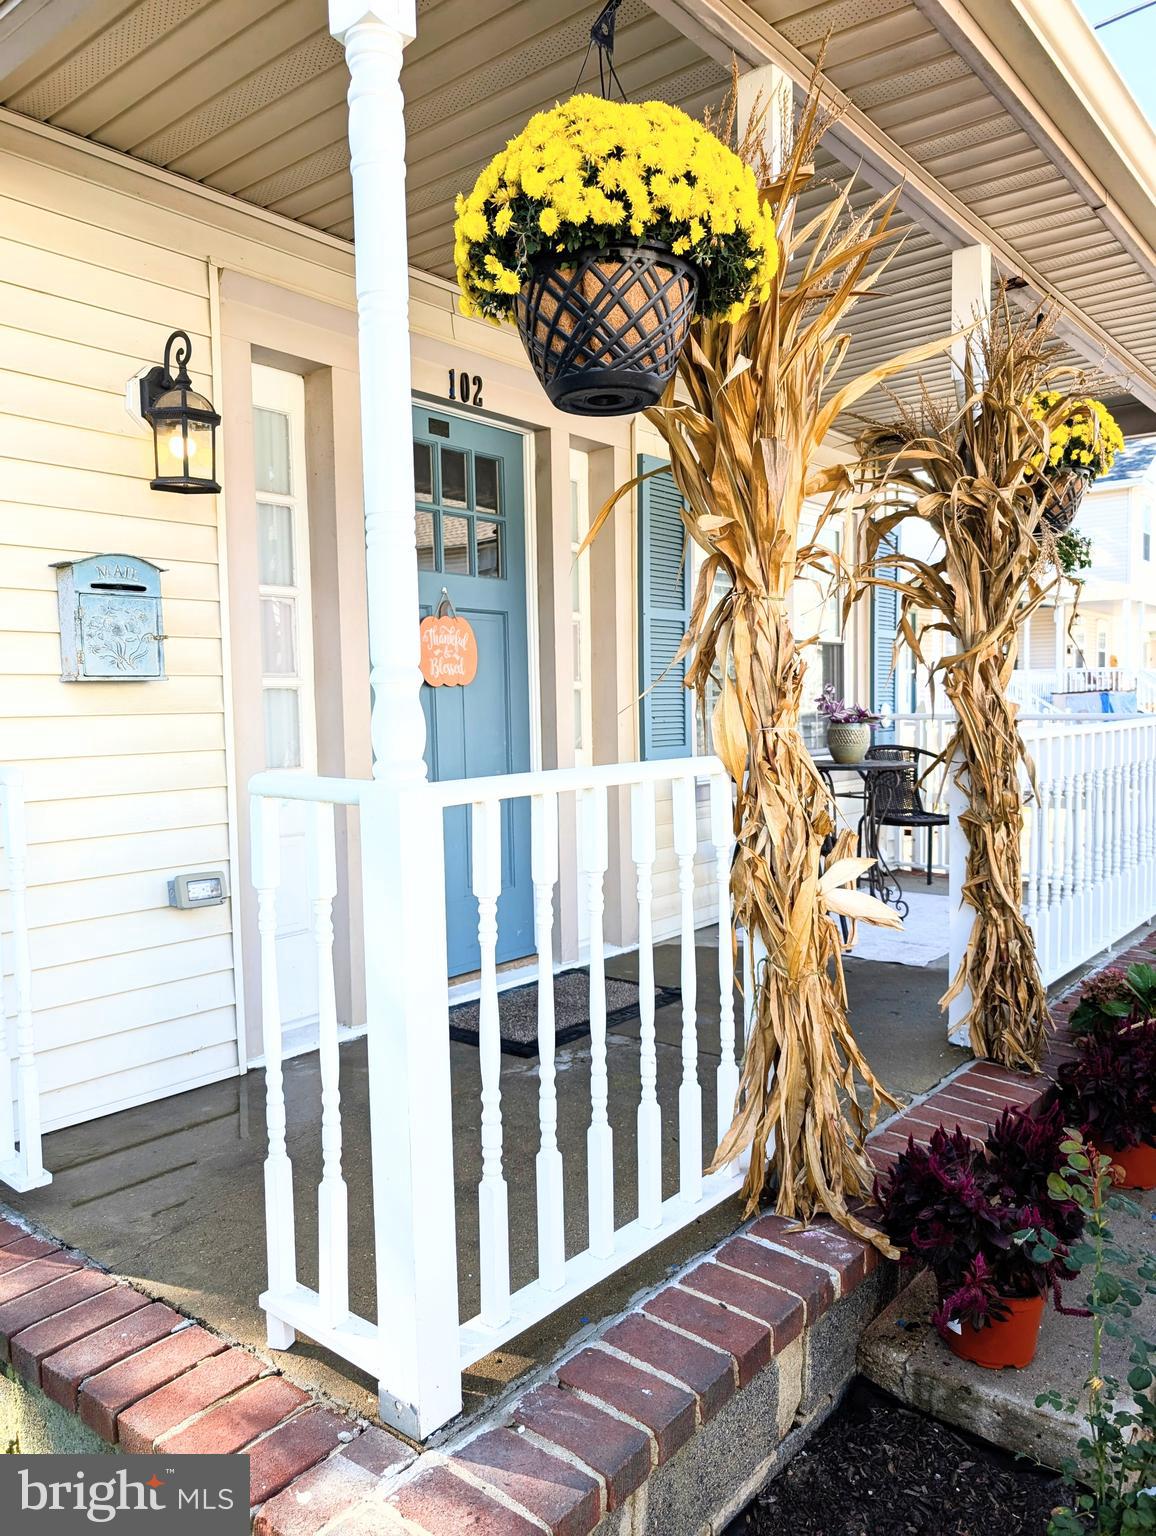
(0, 0), (1156, 420)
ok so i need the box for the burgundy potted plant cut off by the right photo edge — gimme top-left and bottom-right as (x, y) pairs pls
(1050, 966), (1156, 1189)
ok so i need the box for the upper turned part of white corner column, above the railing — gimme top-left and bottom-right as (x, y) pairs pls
(329, 0), (425, 783)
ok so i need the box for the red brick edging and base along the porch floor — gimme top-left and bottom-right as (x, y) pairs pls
(0, 937), (1156, 1536)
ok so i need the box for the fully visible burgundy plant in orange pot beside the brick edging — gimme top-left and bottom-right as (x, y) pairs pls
(875, 1106), (1084, 1369)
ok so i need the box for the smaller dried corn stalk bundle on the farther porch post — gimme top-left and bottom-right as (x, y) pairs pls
(852, 296), (1070, 1071)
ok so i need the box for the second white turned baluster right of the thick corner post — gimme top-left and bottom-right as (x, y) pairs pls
(530, 794), (566, 1290)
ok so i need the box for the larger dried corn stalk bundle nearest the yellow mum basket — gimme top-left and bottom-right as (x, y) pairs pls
(590, 81), (947, 1249)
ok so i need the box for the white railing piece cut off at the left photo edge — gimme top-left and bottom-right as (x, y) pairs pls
(0, 768), (52, 1190)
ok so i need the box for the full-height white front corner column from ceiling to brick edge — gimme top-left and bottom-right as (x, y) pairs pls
(329, 0), (462, 1439)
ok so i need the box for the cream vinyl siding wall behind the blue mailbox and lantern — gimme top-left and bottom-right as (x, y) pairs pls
(0, 123), (353, 1129)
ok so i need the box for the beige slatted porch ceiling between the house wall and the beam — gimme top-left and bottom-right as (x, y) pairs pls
(0, 0), (726, 258)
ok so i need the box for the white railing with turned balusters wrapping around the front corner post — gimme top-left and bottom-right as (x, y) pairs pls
(250, 757), (741, 1436)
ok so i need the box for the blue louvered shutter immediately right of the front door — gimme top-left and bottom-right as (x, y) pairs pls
(639, 453), (694, 759)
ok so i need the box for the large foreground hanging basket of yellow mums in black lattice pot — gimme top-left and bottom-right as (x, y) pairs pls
(454, 95), (778, 416)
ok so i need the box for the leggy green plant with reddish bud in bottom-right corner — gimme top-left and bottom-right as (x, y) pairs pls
(1022, 1130), (1156, 1536)
